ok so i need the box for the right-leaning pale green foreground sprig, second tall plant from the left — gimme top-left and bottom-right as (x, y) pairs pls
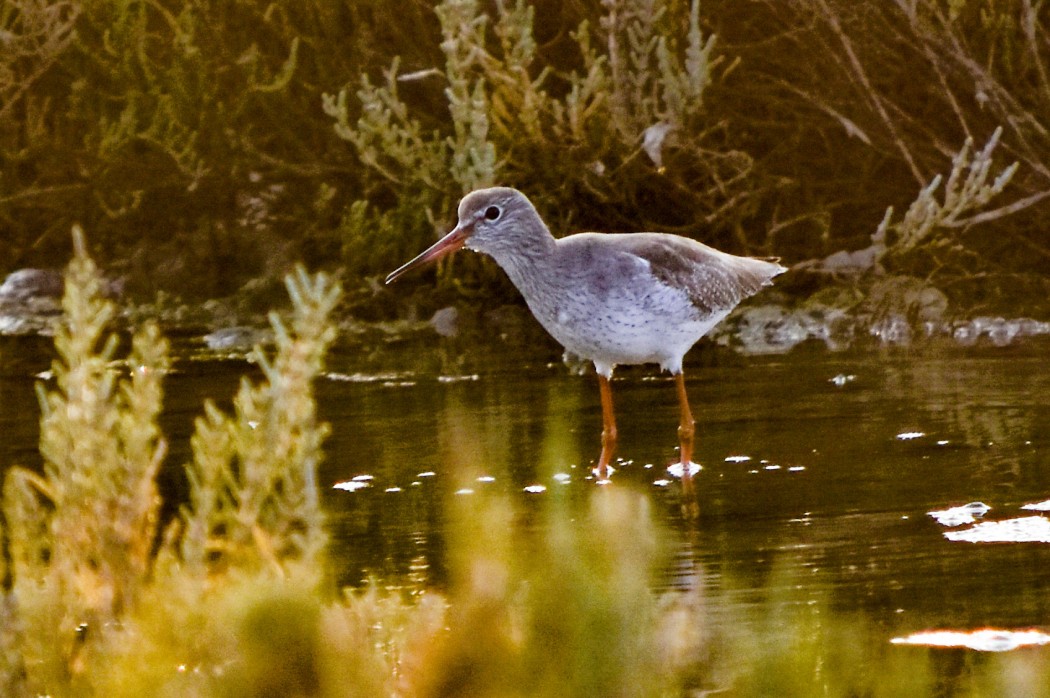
(181, 268), (340, 574)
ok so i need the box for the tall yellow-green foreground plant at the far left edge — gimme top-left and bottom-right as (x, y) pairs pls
(3, 229), (168, 685)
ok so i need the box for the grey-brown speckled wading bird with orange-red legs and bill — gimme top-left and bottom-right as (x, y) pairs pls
(386, 187), (786, 493)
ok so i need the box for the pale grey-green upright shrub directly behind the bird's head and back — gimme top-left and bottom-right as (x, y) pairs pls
(324, 0), (750, 285)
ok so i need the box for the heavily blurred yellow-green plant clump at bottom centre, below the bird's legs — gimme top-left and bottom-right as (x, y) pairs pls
(410, 489), (702, 698)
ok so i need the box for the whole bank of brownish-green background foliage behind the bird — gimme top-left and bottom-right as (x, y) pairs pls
(0, 0), (1050, 310)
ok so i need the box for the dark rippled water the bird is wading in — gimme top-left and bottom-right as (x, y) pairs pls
(0, 333), (1050, 638)
